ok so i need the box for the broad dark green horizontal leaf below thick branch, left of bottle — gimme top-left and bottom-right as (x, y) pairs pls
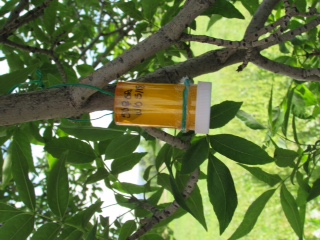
(45, 137), (96, 164)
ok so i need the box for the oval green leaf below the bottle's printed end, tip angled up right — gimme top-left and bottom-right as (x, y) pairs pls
(106, 134), (140, 159)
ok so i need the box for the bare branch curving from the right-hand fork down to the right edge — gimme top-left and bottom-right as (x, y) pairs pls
(251, 54), (320, 82)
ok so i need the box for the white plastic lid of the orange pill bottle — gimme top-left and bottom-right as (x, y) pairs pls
(195, 82), (212, 134)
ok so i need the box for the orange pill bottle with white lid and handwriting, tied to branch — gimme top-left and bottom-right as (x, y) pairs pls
(114, 82), (211, 134)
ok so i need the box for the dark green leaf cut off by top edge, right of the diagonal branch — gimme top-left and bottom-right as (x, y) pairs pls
(202, 0), (245, 19)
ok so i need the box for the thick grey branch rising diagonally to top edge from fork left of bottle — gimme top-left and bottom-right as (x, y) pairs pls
(72, 0), (215, 106)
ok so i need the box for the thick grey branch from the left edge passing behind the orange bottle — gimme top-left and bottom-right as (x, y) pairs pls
(0, 49), (245, 126)
